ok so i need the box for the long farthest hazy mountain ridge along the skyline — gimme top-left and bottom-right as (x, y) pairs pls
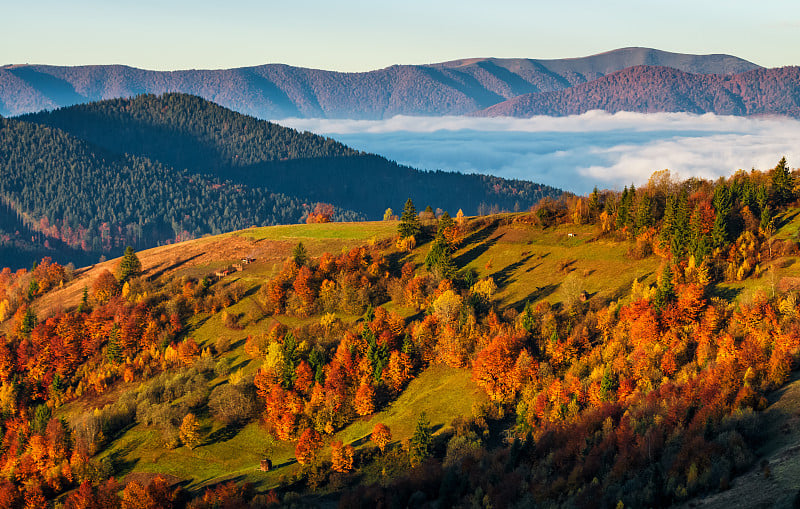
(0, 48), (760, 119)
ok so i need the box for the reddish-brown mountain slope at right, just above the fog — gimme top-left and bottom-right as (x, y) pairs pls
(476, 66), (800, 117)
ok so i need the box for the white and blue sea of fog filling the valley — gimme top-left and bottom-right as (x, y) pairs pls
(278, 111), (800, 193)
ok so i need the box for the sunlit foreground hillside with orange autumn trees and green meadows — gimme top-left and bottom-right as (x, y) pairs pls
(0, 160), (800, 509)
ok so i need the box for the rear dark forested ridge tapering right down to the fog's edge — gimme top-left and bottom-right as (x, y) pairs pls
(21, 94), (559, 219)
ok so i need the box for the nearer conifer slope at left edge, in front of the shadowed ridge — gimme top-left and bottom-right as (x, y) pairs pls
(0, 114), (334, 252)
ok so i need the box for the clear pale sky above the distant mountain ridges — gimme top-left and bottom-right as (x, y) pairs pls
(0, 0), (800, 71)
